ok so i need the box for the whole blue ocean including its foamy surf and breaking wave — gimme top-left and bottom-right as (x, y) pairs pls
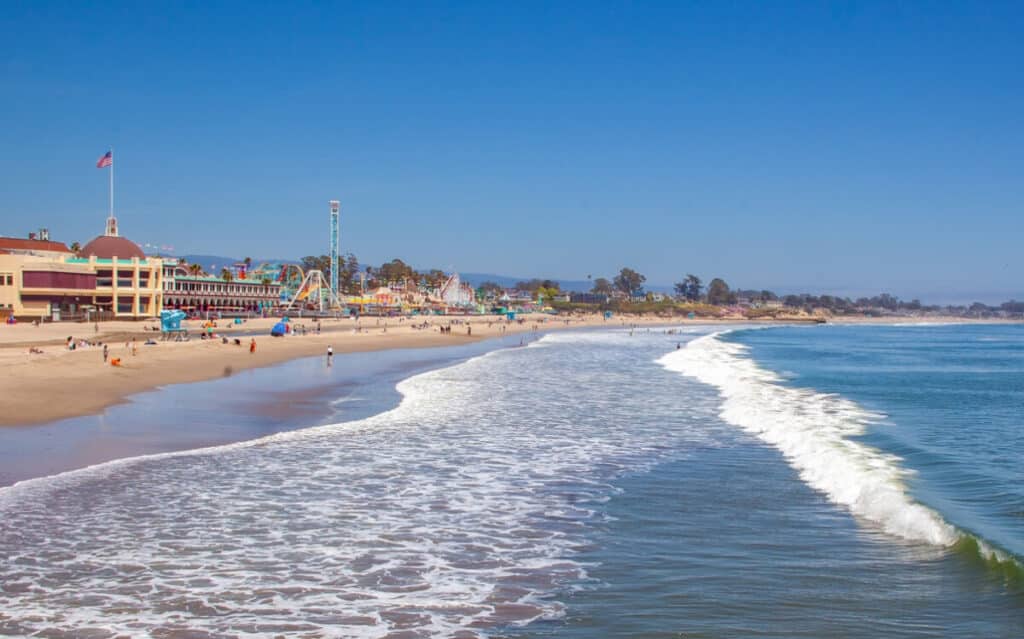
(0, 326), (1024, 639)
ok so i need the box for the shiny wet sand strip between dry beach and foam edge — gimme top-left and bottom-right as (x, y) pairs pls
(0, 336), (532, 486)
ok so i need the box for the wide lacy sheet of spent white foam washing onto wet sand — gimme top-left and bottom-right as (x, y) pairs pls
(0, 329), (707, 637)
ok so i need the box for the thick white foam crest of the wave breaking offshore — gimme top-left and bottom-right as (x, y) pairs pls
(658, 333), (959, 546)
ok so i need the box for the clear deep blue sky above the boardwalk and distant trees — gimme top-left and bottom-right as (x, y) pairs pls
(0, 1), (1024, 301)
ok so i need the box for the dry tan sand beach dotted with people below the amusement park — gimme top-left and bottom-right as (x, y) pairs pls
(0, 314), (1019, 427)
